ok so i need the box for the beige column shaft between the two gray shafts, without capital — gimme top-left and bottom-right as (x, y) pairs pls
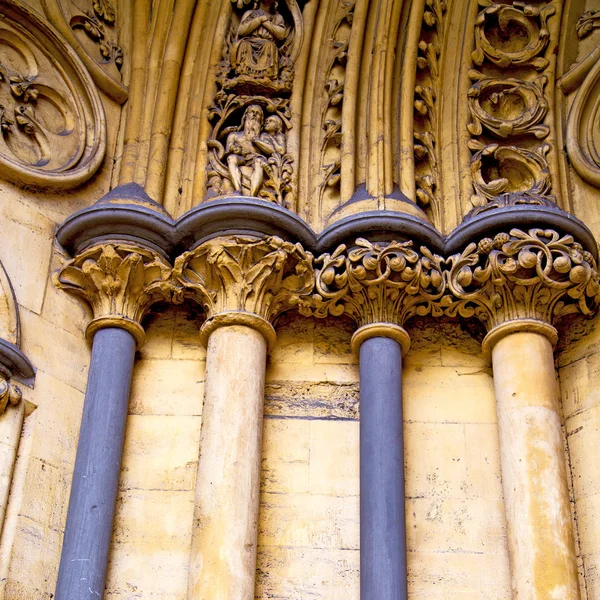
(188, 325), (267, 600)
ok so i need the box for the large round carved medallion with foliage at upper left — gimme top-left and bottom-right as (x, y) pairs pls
(0, 0), (106, 190)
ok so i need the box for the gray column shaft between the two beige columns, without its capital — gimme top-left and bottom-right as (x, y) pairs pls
(360, 337), (407, 600)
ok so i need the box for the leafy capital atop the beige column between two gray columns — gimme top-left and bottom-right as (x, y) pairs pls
(173, 235), (314, 345)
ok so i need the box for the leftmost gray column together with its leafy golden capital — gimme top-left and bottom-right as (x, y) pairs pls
(54, 243), (172, 600)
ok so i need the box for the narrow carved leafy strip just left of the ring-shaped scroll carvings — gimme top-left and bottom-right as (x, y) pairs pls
(414, 0), (448, 223)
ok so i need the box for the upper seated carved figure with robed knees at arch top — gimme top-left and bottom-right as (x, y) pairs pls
(230, 0), (286, 79)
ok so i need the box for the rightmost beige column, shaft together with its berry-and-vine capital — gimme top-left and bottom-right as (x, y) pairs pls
(441, 229), (600, 600)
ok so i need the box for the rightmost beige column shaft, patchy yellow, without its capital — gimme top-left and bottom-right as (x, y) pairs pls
(492, 331), (579, 600)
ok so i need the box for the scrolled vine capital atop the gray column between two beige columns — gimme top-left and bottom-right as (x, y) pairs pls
(307, 238), (445, 351)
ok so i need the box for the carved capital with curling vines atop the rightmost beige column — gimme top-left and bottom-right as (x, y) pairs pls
(441, 229), (600, 351)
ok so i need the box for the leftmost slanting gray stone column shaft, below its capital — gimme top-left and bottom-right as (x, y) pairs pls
(56, 327), (136, 600)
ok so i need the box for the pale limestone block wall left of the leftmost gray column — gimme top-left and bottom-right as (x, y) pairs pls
(0, 86), (121, 600)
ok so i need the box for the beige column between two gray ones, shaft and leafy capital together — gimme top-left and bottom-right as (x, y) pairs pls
(174, 236), (314, 600)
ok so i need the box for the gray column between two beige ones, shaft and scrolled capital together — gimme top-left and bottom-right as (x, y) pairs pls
(309, 239), (445, 600)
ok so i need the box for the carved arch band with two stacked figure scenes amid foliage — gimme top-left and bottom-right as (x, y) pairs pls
(207, 0), (302, 206)
